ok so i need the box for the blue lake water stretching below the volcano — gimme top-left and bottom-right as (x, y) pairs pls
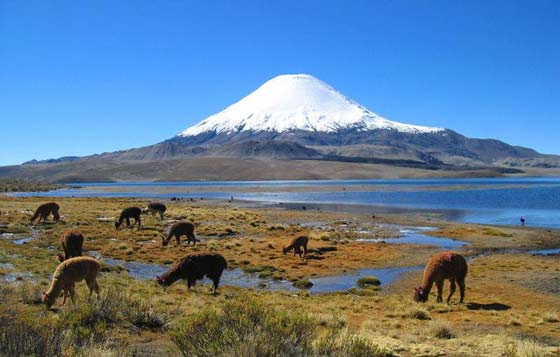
(15, 177), (560, 228)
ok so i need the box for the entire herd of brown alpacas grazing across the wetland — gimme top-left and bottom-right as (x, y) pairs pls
(30, 202), (468, 308)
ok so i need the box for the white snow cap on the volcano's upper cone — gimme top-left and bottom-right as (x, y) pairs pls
(179, 74), (444, 137)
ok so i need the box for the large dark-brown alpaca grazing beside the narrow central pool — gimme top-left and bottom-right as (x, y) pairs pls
(156, 253), (227, 295)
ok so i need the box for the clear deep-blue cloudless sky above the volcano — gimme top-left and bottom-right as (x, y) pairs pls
(0, 0), (560, 165)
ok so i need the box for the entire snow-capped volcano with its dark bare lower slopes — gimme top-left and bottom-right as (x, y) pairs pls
(5, 74), (560, 180)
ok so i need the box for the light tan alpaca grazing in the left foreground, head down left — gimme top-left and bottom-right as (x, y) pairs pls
(41, 257), (100, 309)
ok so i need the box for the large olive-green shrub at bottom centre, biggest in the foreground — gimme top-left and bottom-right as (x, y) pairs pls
(171, 300), (315, 356)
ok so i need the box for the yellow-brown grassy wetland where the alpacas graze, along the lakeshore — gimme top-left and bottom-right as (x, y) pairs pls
(0, 196), (560, 356)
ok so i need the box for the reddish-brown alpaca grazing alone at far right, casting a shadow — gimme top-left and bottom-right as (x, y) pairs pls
(414, 252), (468, 304)
